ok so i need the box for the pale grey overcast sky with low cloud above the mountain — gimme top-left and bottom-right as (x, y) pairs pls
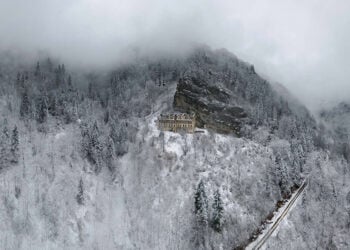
(0, 0), (350, 108)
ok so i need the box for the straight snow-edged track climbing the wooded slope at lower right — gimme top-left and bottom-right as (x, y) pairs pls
(246, 180), (307, 250)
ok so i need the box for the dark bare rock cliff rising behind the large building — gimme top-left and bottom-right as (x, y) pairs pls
(174, 77), (247, 136)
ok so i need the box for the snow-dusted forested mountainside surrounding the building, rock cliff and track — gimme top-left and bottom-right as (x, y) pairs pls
(0, 46), (350, 249)
